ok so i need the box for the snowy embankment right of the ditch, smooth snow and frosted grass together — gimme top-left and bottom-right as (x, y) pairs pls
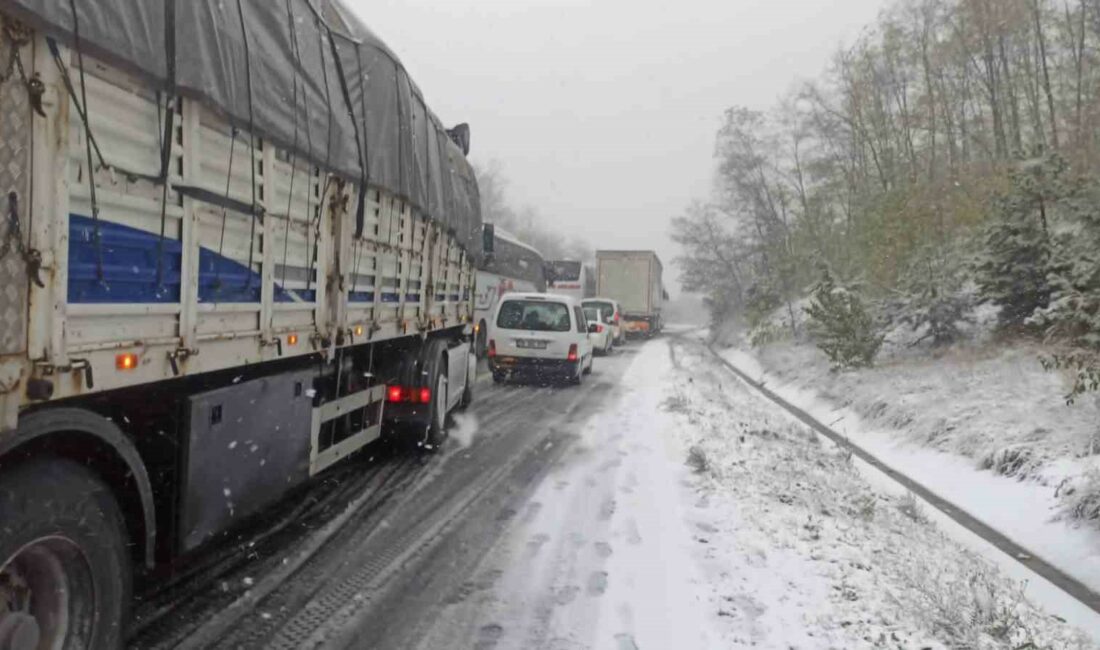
(722, 329), (1100, 607)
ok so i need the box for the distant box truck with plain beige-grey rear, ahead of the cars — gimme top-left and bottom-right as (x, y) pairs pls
(596, 251), (667, 337)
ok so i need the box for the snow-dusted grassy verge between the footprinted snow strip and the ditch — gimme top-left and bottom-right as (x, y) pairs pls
(666, 345), (1089, 648)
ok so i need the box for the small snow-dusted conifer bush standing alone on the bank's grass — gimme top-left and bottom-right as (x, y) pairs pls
(805, 271), (882, 368)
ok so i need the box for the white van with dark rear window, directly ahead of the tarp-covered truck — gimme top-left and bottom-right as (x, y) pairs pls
(488, 294), (595, 384)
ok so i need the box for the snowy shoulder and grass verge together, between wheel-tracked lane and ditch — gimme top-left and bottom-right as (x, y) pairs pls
(415, 338), (1091, 650)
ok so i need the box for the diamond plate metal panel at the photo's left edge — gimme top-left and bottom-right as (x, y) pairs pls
(0, 22), (31, 354)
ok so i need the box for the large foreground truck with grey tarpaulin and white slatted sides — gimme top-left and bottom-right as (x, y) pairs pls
(0, 0), (481, 650)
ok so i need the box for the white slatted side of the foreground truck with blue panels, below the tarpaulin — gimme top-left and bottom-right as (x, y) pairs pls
(0, 36), (474, 428)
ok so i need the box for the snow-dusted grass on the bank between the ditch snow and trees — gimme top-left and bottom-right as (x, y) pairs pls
(718, 312), (1100, 525)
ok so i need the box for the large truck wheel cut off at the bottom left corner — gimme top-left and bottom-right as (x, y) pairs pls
(0, 459), (131, 650)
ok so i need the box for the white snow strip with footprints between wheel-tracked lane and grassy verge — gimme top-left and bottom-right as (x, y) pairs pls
(413, 342), (721, 649)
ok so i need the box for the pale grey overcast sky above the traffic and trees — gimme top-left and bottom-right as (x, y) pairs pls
(347, 0), (886, 288)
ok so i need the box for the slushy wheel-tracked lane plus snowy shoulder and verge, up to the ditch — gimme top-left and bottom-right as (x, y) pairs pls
(141, 334), (1092, 650)
